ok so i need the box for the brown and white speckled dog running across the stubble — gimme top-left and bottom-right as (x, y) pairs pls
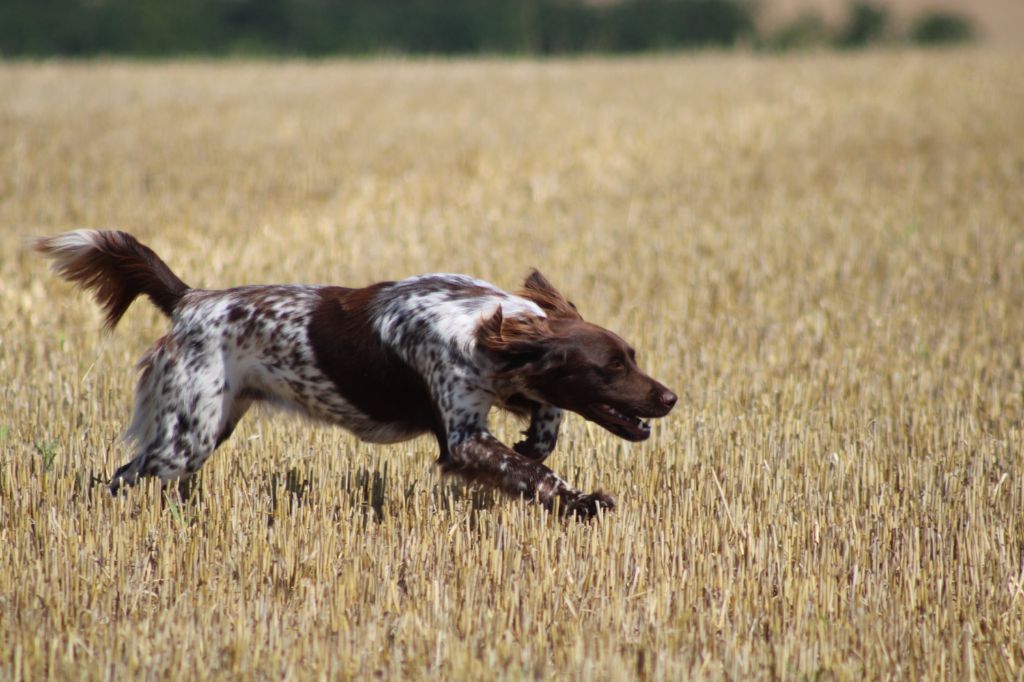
(35, 230), (676, 517)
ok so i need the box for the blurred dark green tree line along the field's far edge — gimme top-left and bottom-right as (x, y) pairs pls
(0, 0), (970, 56)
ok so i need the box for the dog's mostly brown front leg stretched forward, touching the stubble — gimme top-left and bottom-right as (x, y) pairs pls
(442, 430), (615, 518)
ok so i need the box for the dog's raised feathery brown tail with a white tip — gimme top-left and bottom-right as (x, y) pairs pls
(33, 229), (189, 329)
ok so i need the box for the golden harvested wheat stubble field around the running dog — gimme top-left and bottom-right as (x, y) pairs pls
(0, 51), (1024, 680)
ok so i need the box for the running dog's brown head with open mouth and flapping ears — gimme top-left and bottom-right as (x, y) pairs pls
(478, 271), (676, 440)
